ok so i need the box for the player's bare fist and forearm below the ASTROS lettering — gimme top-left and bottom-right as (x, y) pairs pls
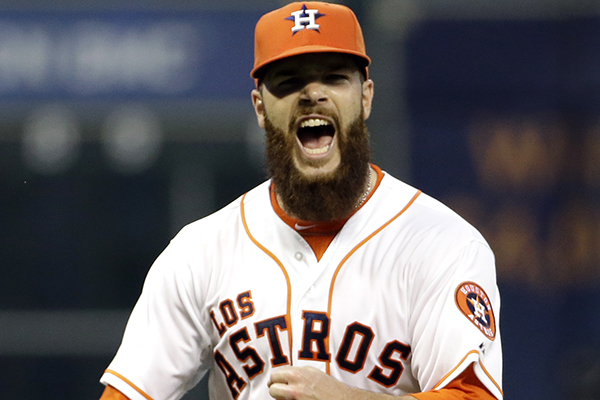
(268, 367), (414, 400)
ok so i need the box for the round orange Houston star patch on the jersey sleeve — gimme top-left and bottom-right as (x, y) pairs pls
(454, 282), (496, 340)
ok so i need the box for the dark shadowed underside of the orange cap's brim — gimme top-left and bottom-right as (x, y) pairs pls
(264, 53), (359, 79)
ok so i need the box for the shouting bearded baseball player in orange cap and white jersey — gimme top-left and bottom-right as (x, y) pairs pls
(101, 2), (503, 400)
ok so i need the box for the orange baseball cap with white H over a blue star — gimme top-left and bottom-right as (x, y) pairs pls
(250, 1), (371, 79)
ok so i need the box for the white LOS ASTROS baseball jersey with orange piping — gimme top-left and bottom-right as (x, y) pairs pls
(101, 170), (502, 400)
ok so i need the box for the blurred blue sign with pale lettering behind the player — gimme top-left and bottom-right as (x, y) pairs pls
(0, 11), (260, 100)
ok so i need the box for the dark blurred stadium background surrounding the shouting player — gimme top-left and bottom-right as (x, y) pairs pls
(0, 0), (600, 400)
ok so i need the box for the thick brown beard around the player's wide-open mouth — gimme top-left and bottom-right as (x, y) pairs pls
(265, 112), (371, 221)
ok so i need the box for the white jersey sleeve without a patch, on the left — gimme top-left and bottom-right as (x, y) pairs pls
(101, 231), (216, 400)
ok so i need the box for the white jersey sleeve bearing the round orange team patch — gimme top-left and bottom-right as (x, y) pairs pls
(411, 238), (503, 399)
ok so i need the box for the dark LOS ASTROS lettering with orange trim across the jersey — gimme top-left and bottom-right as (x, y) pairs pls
(210, 290), (411, 399)
